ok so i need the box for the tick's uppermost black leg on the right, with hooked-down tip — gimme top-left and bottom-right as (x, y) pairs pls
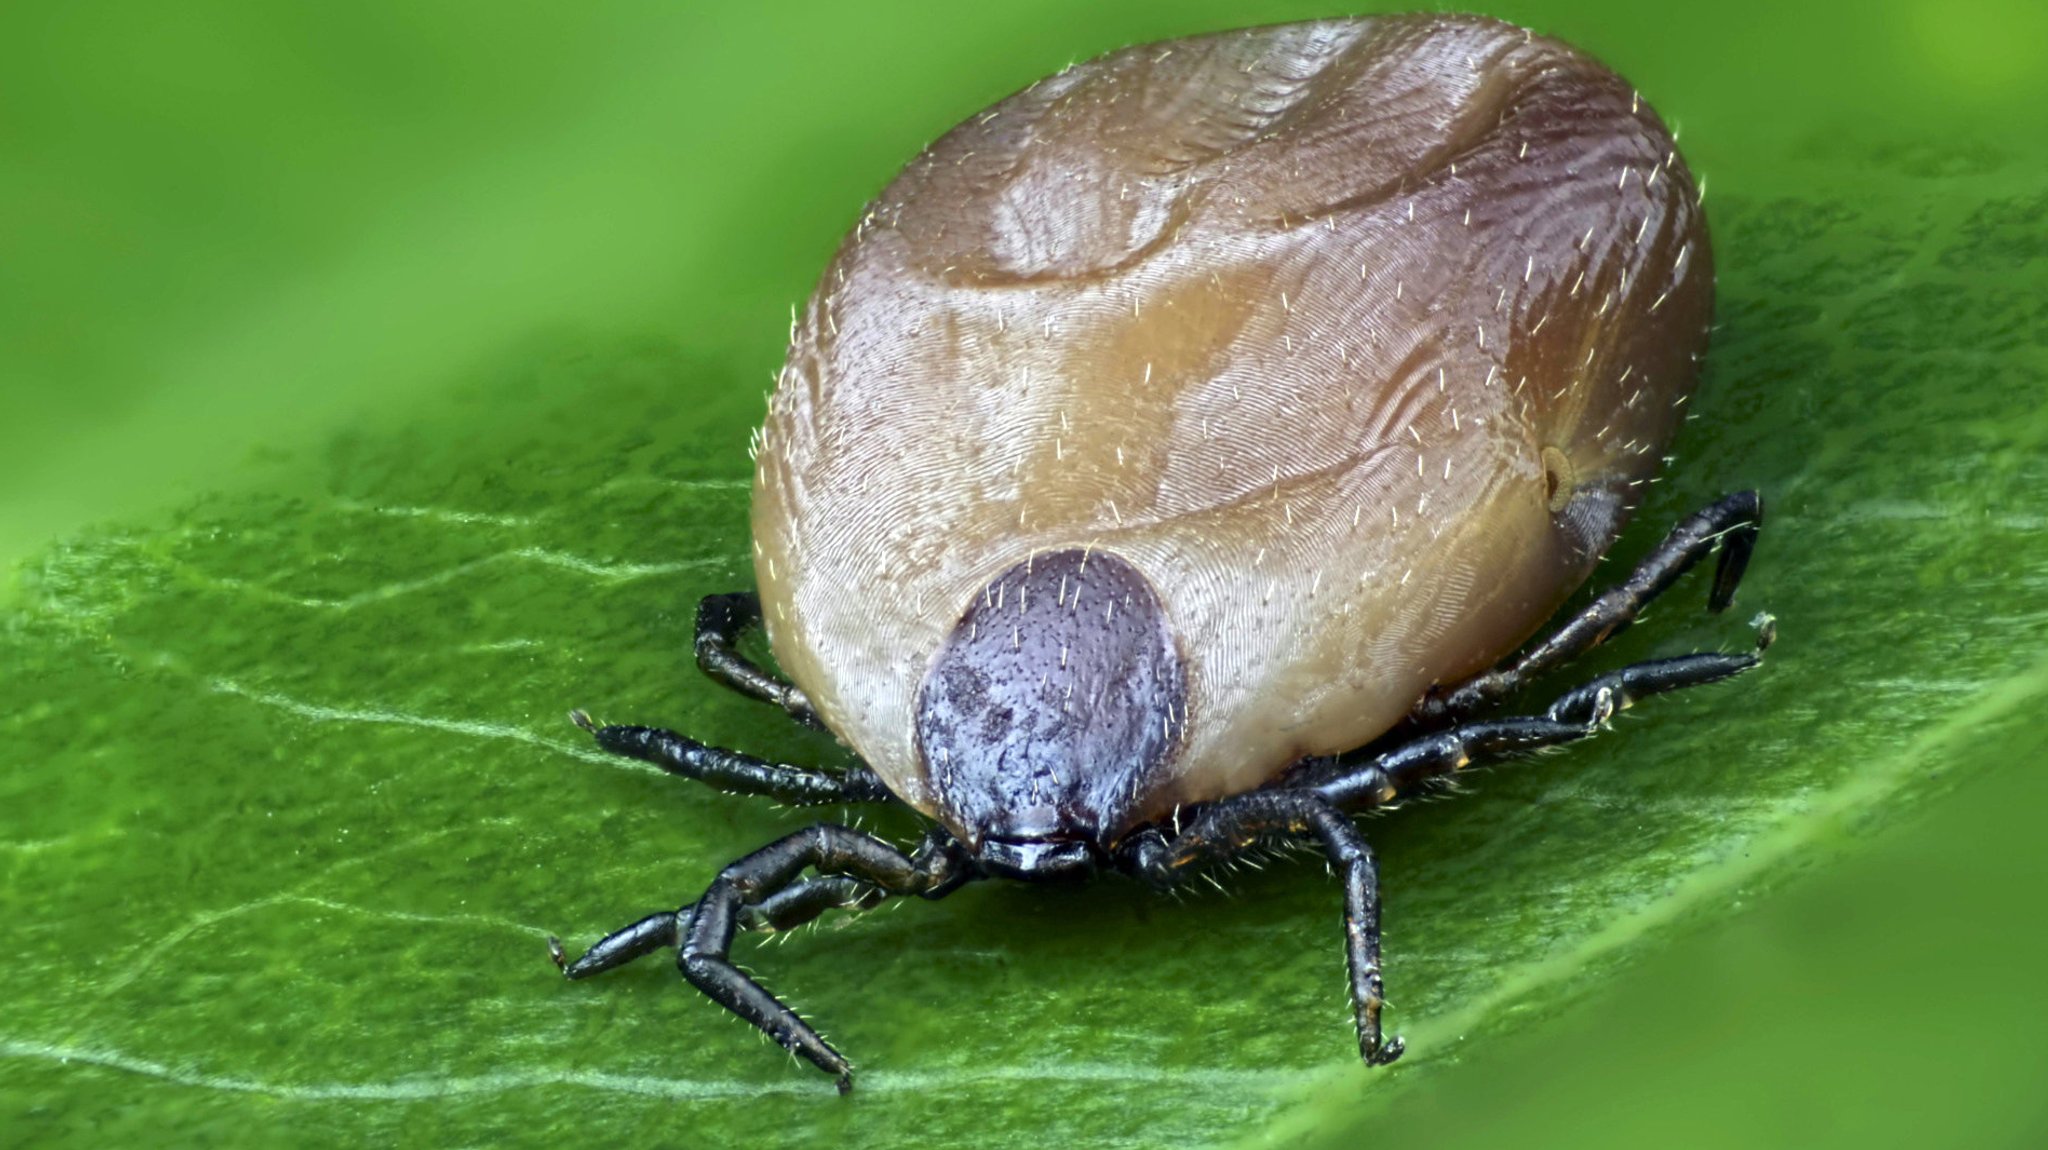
(1413, 491), (1763, 726)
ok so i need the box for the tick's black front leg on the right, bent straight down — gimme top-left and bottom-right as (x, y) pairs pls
(1122, 790), (1401, 1066)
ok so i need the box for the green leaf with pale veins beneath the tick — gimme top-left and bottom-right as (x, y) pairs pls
(0, 2), (2048, 1146)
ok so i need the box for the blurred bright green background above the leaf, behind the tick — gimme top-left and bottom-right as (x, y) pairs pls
(0, 0), (2048, 581)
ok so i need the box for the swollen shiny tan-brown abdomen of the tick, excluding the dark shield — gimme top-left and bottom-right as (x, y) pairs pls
(754, 16), (1712, 839)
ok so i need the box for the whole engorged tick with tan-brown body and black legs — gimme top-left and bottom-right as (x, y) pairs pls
(557, 16), (1769, 1089)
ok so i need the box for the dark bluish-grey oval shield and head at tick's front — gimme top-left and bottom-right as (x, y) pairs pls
(918, 550), (1188, 880)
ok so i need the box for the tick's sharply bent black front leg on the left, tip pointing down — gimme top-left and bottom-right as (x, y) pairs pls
(684, 823), (971, 1093)
